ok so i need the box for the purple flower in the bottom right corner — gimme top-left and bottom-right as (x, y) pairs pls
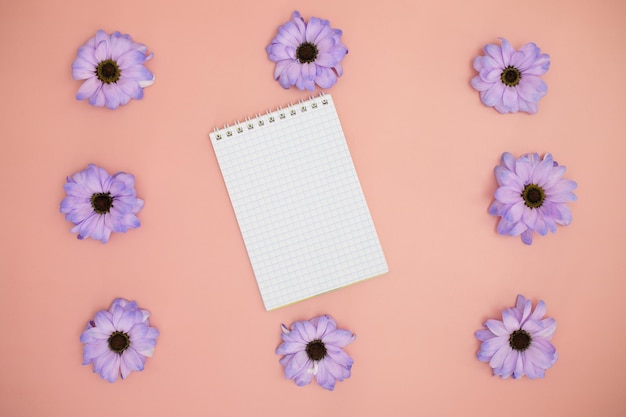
(476, 295), (558, 379)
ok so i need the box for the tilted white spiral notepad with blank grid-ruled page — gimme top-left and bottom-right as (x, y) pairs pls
(209, 94), (388, 310)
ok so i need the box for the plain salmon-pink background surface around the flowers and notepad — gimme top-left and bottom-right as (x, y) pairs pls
(0, 0), (626, 417)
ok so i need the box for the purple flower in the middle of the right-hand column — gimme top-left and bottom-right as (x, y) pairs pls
(489, 152), (577, 245)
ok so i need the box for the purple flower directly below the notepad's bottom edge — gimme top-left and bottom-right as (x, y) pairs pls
(276, 316), (356, 391)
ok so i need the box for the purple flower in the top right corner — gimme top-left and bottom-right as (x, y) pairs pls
(472, 38), (550, 114)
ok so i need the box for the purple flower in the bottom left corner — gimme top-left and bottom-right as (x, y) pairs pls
(80, 298), (159, 382)
